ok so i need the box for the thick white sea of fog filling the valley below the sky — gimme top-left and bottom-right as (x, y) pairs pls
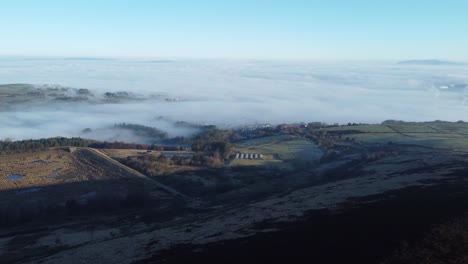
(0, 57), (468, 139)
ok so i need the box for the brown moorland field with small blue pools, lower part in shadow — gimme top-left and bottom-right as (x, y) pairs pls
(0, 149), (174, 204)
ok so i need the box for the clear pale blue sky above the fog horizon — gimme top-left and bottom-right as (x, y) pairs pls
(0, 0), (468, 61)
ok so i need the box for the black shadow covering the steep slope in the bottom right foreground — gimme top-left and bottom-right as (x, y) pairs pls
(139, 179), (468, 264)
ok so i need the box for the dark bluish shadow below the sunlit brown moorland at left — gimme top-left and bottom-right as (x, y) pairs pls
(0, 178), (186, 230)
